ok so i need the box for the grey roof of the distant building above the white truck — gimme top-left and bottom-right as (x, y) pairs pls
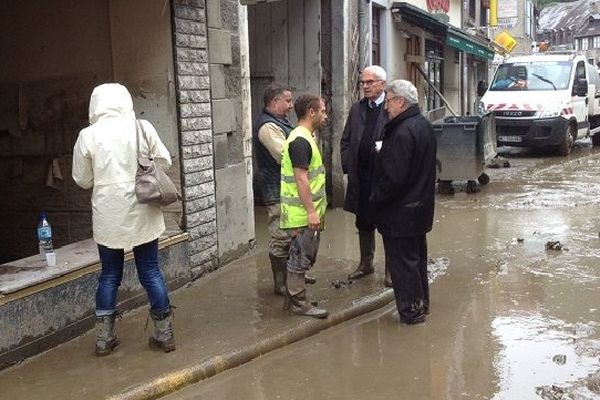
(538, 0), (597, 32)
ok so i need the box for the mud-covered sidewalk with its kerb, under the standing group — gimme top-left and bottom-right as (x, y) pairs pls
(0, 208), (393, 400)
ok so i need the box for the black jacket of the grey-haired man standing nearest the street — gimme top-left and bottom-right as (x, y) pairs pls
(369, 105), (436, 237)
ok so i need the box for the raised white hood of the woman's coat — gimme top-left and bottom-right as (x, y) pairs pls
(89, 83), (135, 125)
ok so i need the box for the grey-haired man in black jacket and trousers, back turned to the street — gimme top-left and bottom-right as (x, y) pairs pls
(369, 80), (436, 324)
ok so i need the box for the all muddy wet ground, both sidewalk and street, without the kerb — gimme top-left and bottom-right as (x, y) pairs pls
(0, 144), (600, 400)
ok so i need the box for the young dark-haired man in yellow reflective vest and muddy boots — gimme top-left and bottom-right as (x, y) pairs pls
(280, 95), (329, 318)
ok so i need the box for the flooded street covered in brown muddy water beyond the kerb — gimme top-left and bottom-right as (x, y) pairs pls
(169, 145), (600, 400)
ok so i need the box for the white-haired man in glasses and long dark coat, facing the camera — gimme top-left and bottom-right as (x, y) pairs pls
(340, 65), (392, 286)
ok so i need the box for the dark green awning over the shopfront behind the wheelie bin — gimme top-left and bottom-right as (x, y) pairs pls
(392, 2), (494, 61)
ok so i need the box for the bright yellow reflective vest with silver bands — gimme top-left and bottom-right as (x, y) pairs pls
(280, 126), (327, 229)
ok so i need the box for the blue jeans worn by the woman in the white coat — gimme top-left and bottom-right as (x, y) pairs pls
(96, 239), (170, 317)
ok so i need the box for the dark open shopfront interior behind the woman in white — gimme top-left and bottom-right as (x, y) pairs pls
(0, 1), (182, 266)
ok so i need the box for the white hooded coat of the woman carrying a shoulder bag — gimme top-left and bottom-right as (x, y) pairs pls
(73, 83), (171, 251)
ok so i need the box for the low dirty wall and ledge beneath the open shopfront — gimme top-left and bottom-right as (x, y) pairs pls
(0, 233), (191, 370)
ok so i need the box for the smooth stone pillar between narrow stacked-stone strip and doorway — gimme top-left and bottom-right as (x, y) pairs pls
(206, 0), (254, 263)
